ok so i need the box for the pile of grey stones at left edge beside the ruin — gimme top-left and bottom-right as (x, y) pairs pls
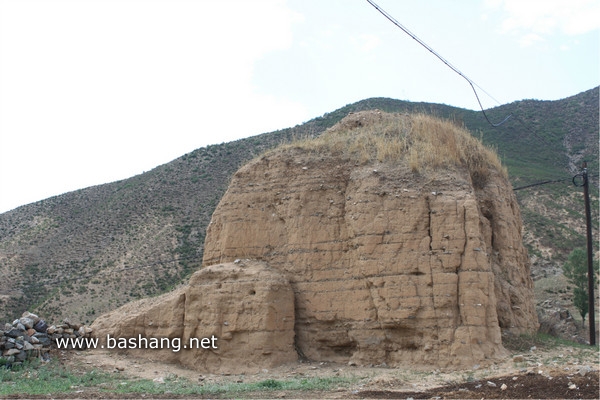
(0, 311), (92, 366)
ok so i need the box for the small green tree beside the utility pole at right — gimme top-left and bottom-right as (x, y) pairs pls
(563, 248), (598, 326)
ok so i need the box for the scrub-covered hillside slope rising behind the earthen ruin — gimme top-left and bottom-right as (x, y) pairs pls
(0, 88), (598, 322)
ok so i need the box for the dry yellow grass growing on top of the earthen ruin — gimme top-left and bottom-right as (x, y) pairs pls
(278, 110), (508, 184)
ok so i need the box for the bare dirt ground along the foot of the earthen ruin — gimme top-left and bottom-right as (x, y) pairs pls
(37, 347), (600, 399)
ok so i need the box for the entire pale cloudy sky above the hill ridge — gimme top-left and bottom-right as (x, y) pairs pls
(0, 0), (600, 213)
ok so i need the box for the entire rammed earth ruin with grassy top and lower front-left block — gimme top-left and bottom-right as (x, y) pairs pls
(93, 111), (538, 373)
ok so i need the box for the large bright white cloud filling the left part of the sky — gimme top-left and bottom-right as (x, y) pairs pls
(0, 0), (306, 212)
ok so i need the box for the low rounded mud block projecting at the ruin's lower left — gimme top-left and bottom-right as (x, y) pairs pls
(92, 260), (297, 373)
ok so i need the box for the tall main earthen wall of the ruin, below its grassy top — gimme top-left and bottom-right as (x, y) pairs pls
(204, 111), (537, 367)
